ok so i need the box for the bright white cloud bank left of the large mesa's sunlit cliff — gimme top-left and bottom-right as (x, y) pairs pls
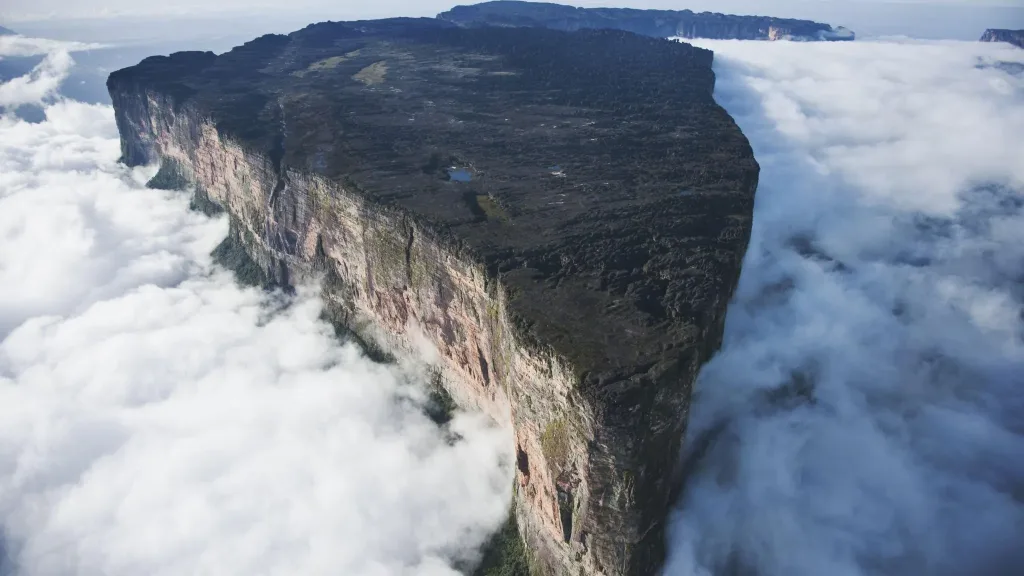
(0, 39), (512, 576)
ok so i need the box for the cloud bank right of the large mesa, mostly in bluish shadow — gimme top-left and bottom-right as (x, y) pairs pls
(666, 42), (1024, 576)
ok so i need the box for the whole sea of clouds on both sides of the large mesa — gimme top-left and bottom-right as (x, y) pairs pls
(0, 26), (1024, 576)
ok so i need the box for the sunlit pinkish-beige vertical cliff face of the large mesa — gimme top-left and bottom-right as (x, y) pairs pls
(112, 86), (696, 576)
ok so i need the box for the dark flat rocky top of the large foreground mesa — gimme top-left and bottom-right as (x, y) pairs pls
(110, 20), (757, 376)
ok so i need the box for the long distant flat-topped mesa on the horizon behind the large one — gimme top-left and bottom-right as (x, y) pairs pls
(437, 0), (854, 41)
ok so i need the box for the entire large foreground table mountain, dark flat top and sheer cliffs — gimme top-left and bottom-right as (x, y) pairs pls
(108, 18), (758, 576)
